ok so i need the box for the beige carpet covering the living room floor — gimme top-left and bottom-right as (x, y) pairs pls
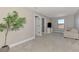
(10, 33), (79, 52)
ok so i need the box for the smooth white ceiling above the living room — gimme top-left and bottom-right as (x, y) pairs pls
(31, 7), (79, 17)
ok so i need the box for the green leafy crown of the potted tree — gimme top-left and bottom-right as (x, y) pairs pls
(0, 11), (26, 31)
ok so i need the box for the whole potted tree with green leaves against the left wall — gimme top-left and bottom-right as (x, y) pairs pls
(0, 11), (26, 51)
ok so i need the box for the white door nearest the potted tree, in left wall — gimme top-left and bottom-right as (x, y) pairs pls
(35, 16), (42, 36)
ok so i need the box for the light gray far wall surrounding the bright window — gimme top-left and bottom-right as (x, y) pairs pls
(52, 15), (74, 32)
